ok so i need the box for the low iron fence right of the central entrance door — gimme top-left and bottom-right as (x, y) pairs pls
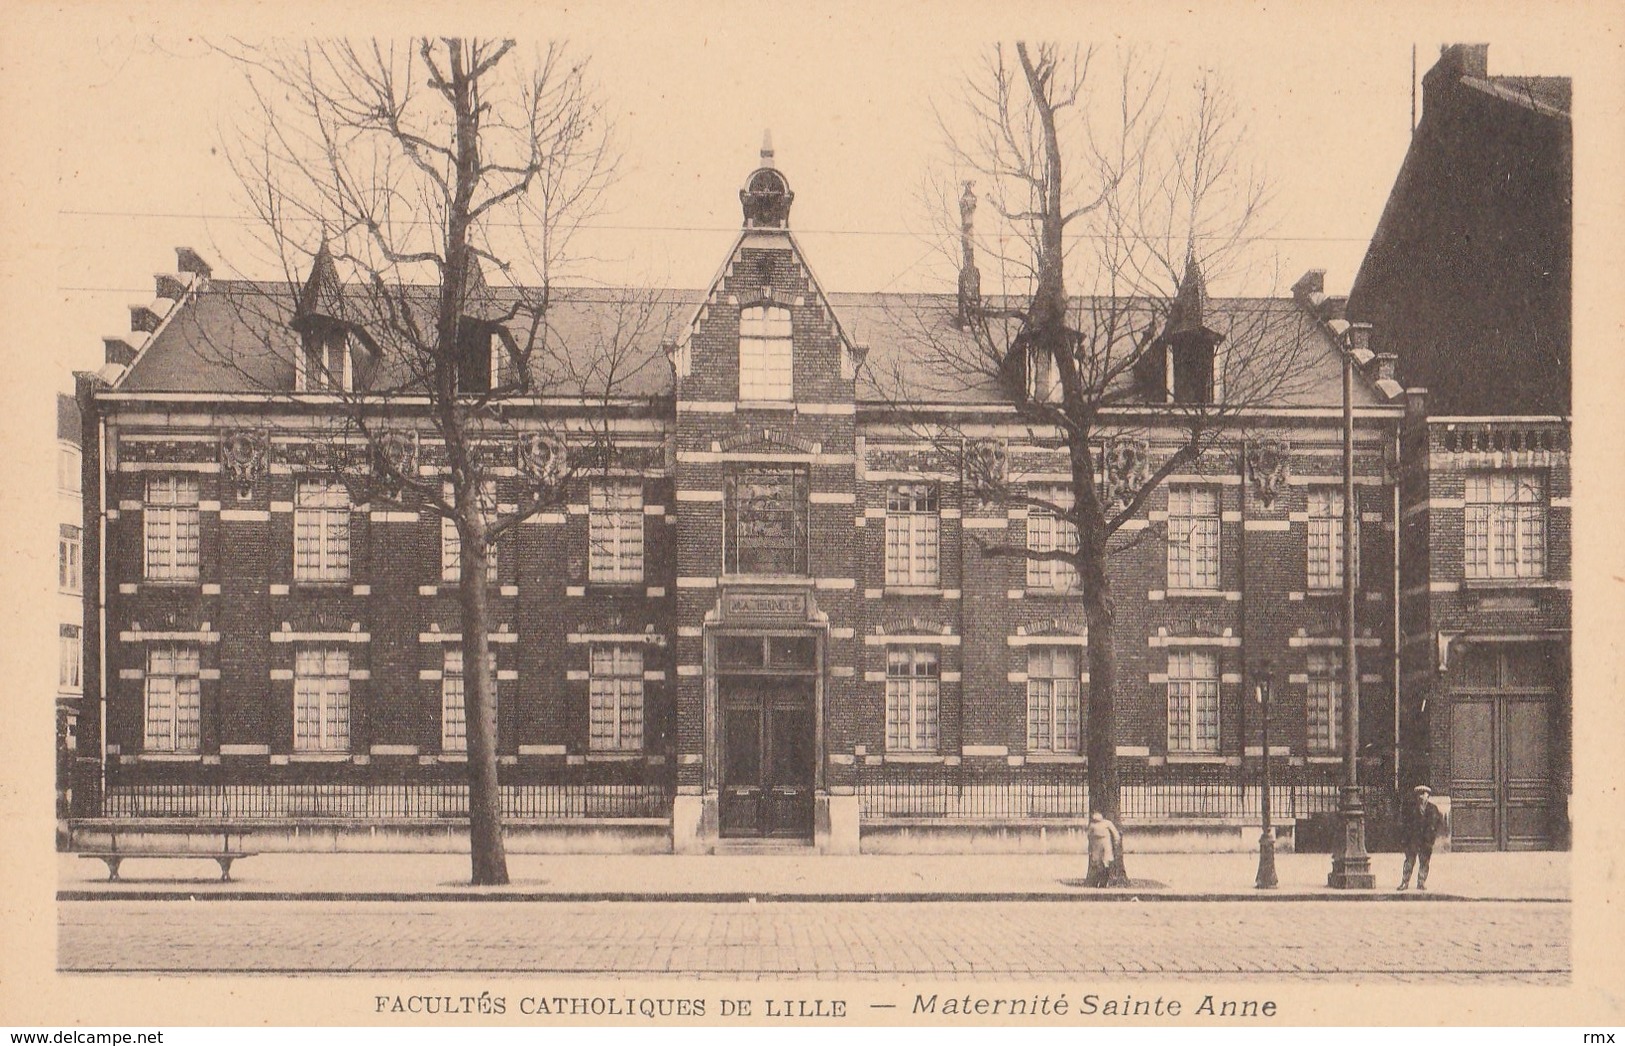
(856, 763), (1389, 820)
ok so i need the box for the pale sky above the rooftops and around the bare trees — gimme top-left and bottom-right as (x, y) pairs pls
(28, 6), (1570, 388)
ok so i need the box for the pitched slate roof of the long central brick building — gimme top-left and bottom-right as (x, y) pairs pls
(117, 277), (1381, 406)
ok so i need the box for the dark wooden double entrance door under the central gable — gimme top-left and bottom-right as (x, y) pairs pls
(720, 679), (816, 838)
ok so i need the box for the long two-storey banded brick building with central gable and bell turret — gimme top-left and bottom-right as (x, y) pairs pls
(80, 145), (1423, 853)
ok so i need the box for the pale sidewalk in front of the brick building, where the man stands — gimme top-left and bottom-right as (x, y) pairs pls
(57, 853), (1570, 901)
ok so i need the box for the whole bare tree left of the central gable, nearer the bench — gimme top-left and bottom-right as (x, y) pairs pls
(211, 39), (663, 884)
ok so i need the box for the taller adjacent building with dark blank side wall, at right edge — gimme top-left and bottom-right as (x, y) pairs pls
(1347, 44), (1573, 849)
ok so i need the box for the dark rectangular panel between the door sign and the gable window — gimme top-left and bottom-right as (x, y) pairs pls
(723, 468), (808, 575)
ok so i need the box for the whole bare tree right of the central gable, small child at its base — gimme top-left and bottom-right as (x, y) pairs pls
(873, 44), (1311, 884)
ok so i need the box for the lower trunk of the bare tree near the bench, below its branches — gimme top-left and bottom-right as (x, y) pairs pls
(458, 532), (509, 887)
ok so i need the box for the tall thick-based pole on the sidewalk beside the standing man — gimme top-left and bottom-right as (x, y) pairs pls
(1326, 331), (1376, 890)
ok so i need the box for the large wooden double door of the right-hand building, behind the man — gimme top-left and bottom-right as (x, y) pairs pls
(1450, 646), (1557, 849)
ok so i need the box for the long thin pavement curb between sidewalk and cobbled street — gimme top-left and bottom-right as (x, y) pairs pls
(57, 887), (1570, 905)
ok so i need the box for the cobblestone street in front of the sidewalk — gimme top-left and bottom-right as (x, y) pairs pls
(59, 900), (1570, 984)
